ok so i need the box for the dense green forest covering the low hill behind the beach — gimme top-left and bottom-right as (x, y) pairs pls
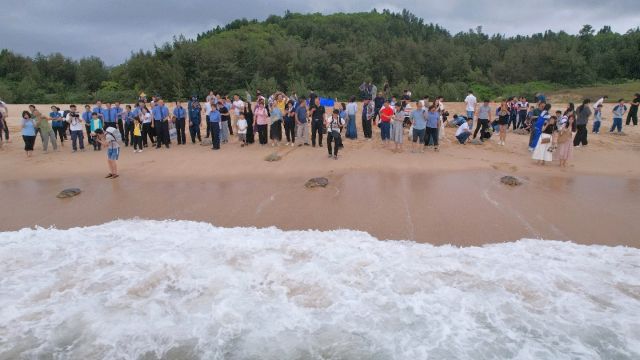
(0, 10), (640, 103)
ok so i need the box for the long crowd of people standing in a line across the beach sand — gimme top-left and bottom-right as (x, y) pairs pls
(0, 88), (640, 178)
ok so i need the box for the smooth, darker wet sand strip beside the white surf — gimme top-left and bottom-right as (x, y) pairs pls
(3, 170), (640, 248)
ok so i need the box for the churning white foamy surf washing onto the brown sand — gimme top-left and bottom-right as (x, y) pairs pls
(0, 220), (640, 359)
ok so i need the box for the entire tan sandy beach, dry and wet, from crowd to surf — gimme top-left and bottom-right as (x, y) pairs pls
(0, 103), (640, 247)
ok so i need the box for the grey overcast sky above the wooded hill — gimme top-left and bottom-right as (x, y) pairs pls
(0, 0), (640, 65)
